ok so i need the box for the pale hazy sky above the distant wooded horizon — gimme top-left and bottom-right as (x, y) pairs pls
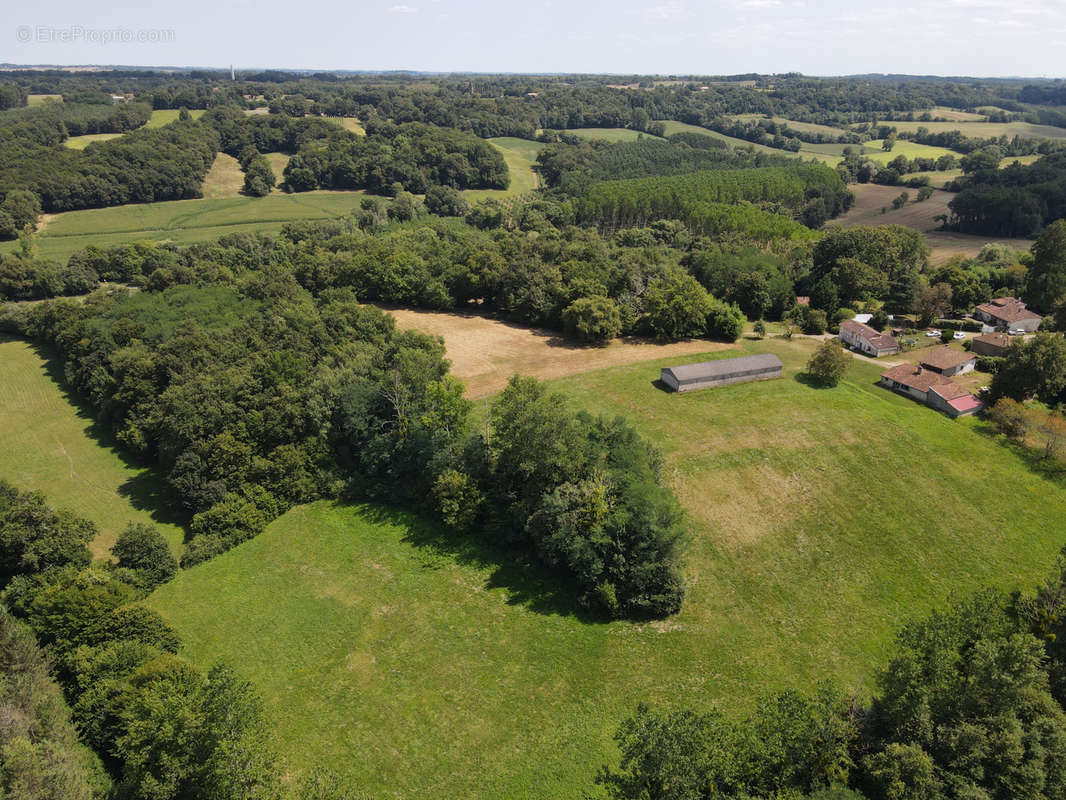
(6, 0), (1066, 77)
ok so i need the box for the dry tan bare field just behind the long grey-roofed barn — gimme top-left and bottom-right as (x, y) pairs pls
(387, 308), (732, 398)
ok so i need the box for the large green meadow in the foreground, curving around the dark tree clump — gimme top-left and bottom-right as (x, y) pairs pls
(150, 339), (1066, 798)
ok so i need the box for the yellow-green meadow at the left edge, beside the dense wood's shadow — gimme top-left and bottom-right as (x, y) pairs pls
(0, 337), (182, 557)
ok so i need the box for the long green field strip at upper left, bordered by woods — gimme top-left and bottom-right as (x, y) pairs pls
(0, 192), (379, 260)
